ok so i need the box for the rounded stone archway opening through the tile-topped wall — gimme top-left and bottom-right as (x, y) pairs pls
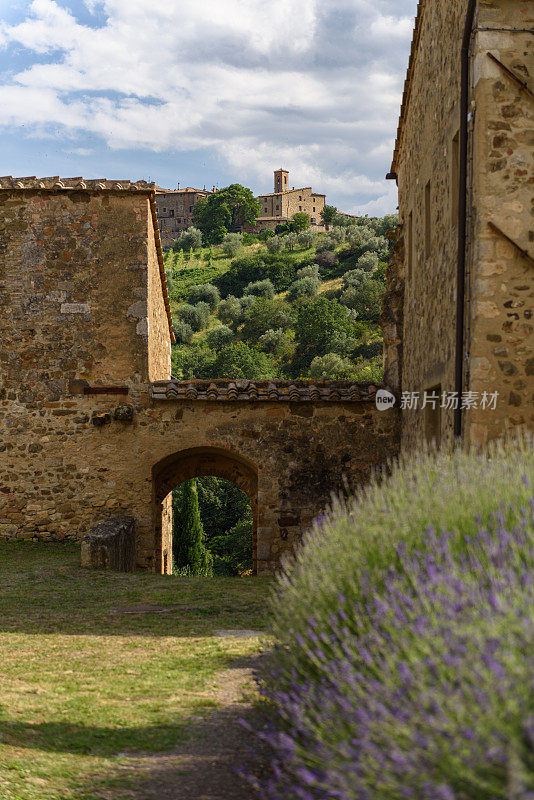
(152, 447), (258, 575)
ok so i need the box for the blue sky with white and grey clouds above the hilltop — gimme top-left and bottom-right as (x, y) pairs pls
(0, 0), (417, 215)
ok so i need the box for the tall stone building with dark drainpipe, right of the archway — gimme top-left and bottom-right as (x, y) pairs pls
(382, 0), (534, 448)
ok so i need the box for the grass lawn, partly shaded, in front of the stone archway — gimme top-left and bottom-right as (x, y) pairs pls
(0, 542), (269, 800)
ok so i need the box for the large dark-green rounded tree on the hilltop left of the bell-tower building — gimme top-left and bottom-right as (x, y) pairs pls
(193, 183), (260, 244)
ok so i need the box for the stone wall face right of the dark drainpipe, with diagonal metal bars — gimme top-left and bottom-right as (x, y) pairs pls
(465, 0), (534, 444)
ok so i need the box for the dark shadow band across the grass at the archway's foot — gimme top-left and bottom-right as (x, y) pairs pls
(0, 542), (271, 637)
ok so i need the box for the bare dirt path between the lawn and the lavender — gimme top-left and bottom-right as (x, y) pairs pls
(104, 636), (266, 800)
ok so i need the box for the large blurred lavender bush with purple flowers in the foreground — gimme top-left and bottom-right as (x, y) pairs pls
(253, 441), (534, 800)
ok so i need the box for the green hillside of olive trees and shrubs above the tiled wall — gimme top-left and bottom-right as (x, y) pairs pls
(165, 215), (397, 381)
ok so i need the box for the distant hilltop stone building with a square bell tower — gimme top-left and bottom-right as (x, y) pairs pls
(255, 169), (326, 231)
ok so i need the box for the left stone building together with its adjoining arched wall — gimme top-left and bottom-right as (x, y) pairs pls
(0, 178), (398, 573)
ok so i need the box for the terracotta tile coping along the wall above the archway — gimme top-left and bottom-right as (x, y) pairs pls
(151, 379), (392, 403)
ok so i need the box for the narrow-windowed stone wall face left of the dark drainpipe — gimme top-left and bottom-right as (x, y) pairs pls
(397, 0), (467, 449)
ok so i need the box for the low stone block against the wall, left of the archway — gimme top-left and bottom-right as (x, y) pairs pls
(81, 516), (135, 572)
